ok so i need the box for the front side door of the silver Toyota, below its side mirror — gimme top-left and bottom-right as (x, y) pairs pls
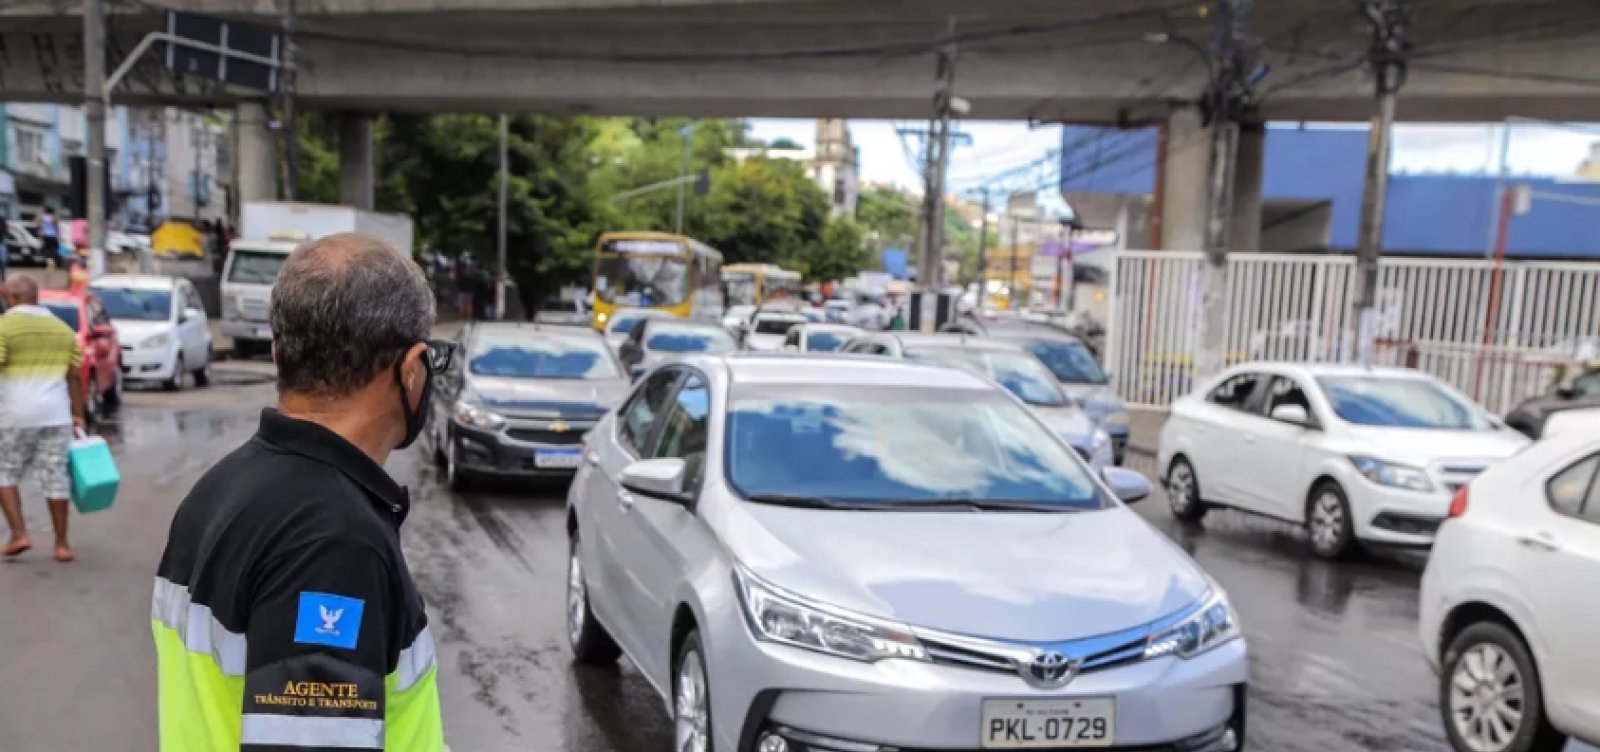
(616, 368), (710, 678)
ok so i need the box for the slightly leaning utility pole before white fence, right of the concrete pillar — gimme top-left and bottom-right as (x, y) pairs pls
(1355, 0), (1411, 363)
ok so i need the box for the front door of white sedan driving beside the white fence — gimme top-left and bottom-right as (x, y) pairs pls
(1238, 376), (1322, 520)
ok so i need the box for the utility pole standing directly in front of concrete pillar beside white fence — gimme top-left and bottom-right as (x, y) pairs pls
(1194, 0), (1261, 378)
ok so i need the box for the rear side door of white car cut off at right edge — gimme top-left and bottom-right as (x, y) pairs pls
(1507, 453), (1600, 736)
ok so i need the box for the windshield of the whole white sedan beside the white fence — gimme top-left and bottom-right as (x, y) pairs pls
(1317, 376), (1493, 430)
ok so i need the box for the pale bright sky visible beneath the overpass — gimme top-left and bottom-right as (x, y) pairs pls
(750, 118), (1600, 195)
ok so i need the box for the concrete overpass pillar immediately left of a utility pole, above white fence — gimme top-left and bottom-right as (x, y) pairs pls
(1157, 107), (1211, 251)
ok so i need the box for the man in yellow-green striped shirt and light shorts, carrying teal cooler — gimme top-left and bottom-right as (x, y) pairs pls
(0, 277), (83, 562)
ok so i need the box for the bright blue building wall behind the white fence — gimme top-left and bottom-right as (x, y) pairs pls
(1061, 126), (1600, 259)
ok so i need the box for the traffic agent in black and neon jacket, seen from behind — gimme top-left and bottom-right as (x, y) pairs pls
(150, 234), (453, 752)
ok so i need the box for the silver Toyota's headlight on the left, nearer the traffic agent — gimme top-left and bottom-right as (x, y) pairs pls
(733, 566), (928, 662)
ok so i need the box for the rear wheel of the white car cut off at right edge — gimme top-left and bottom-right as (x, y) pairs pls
(1438, 621), (1566, 752)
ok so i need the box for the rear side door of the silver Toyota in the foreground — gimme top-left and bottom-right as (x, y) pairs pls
(581, 366), (682, 659)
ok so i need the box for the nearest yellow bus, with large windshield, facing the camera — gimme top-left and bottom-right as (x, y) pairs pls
(592, 232), (722, 330)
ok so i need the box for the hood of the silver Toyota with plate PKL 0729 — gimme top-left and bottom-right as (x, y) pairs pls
(722, 502), (1210, 642)
